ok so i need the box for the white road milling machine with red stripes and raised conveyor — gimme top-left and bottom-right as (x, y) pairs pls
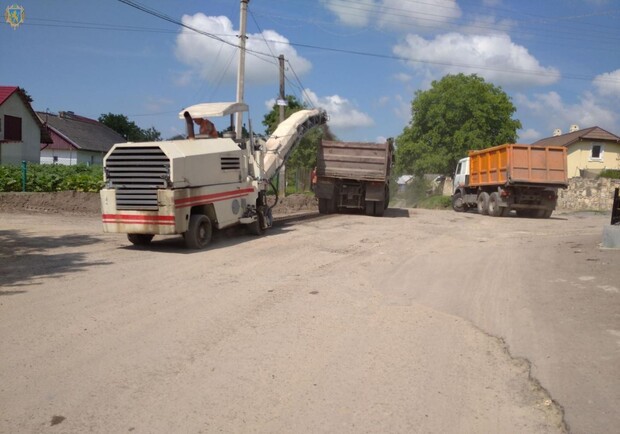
(100, 102), (327, 249)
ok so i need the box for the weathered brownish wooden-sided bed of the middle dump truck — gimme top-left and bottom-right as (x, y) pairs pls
(317, 140), (391, 181)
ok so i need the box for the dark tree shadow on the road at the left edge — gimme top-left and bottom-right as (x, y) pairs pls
(0, 230), (106, 296)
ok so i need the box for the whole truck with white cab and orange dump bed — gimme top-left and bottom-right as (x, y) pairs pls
(452, 144), (568, 218)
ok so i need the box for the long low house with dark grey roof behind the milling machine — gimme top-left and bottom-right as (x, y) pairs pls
(37, 111), (127, 165)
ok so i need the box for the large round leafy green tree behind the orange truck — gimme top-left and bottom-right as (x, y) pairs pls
(396, 74), (521, 175)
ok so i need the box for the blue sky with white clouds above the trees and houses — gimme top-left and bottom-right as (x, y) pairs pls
(0, 0), (620, 143)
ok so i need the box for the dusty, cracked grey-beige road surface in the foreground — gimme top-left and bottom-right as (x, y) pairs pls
(0, 209), (620, 433)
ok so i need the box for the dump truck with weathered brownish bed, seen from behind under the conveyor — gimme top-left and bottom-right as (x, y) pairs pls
(314, 139), (394, 216)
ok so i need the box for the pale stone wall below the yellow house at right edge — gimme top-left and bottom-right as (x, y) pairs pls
(558, 178), (620, 212)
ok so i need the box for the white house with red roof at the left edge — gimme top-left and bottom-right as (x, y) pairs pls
(0, 86), (51, 164)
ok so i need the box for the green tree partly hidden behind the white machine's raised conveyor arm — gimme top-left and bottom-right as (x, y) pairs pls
(263, 95), (336, 169)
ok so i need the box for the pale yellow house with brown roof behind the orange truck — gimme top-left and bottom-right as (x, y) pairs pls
(532, 125), (620, 178)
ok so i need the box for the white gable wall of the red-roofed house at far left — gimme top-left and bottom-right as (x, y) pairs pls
(0, 93), (41, 164)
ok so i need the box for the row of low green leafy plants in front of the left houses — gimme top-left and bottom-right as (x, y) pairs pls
(0, 163), (103, 193)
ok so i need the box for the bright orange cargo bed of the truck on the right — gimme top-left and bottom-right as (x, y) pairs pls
(469, 144), (568, 187)
